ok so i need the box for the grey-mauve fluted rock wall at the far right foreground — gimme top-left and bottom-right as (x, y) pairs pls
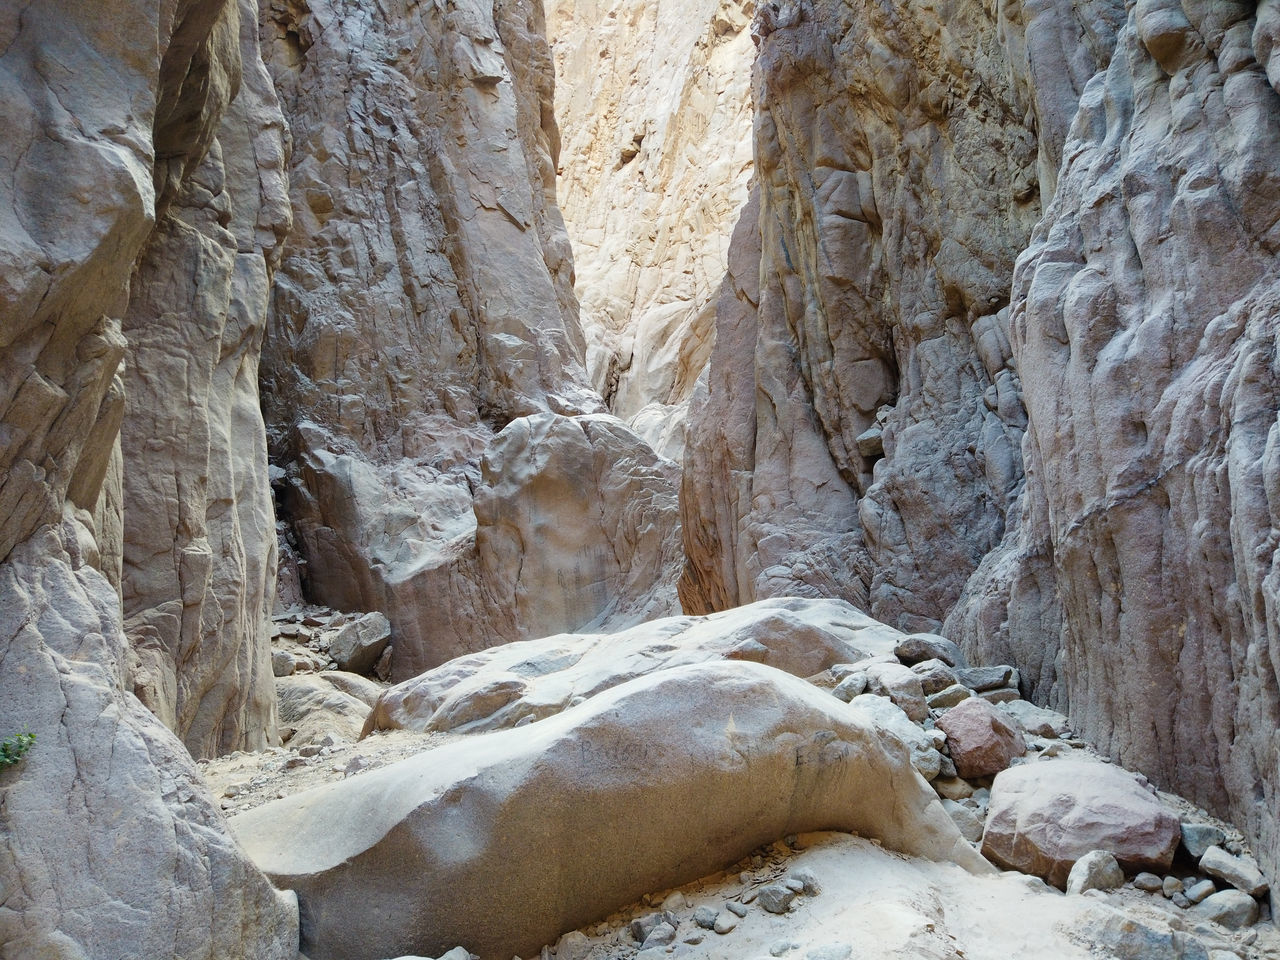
(948, 1), (1280, 877)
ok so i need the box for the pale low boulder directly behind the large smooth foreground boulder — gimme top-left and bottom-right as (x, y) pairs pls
(366, 598), (901, 732)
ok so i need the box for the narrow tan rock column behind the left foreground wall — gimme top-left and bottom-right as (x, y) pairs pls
(120, 4), (289, 756)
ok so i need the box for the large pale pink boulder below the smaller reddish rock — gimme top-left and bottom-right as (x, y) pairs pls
(977, 762), (1180, 887)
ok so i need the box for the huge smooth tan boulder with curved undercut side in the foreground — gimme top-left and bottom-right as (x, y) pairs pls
(232, 663), (987, 960)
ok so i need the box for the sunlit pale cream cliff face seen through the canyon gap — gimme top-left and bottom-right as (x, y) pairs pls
(547, 0), (754, 461)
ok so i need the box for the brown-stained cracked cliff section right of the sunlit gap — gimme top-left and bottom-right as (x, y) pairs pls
(681, 0), (1085, 630)
